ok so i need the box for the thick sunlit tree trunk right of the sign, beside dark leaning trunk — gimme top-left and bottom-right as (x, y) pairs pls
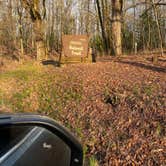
(112, 0), (123, 56)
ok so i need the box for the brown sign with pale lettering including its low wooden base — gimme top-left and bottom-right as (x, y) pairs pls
(61, 35), (91, 63)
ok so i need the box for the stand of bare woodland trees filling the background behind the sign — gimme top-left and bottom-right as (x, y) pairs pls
(0, 0), (166, 61)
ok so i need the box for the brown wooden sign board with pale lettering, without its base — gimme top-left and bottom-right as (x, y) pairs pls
(62, 35), (89, 58)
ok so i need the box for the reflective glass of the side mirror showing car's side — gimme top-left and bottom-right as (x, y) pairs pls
(0, 126), (71, 166)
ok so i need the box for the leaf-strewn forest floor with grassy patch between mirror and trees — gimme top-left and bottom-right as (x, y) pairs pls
(0, 56), (166, 166)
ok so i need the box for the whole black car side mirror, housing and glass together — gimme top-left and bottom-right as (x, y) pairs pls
(0, 114), (83, 166)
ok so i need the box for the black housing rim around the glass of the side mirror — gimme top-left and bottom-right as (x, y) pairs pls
(0, 114), (83, 166)
